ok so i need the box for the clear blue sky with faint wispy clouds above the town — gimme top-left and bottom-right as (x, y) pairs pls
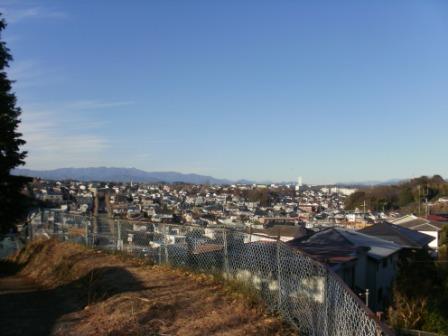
(0, 0), (448, 184)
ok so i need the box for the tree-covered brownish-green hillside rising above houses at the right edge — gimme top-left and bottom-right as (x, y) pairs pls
(345, 175), (448, 212)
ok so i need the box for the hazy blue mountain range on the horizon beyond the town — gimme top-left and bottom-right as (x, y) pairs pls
(12, 167), (242, 184)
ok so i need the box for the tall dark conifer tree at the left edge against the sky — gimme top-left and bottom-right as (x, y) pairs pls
(0, 14), (27, 232)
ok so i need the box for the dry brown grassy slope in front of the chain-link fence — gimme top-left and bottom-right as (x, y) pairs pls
(0, 240), (294, 335)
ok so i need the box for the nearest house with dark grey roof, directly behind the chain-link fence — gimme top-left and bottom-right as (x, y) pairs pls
(287, 228), (401, 311)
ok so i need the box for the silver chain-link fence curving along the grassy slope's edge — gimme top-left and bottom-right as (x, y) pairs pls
(29, 210), (385, 336)
